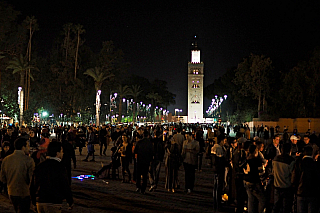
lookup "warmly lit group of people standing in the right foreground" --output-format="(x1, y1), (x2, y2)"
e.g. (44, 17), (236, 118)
(211, 128), (320, 213)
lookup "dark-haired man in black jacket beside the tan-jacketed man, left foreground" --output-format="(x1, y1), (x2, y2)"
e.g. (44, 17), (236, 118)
(30, 142), (73, 212)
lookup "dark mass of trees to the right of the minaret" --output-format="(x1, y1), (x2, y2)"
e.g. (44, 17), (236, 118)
(205, 48), (320, 123)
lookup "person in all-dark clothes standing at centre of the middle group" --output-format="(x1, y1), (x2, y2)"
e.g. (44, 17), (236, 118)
(134, 131), (154, 194)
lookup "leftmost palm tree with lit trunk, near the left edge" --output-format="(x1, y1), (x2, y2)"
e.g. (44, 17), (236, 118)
(6, 54), (37, 125)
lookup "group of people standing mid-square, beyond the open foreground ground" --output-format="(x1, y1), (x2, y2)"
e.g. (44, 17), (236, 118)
(93, 126), (204, 194)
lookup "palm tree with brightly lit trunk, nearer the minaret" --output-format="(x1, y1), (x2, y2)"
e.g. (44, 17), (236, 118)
(84, 67), (114, 126)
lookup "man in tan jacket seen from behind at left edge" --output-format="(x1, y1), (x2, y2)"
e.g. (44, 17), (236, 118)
(0, 138), (35, 213)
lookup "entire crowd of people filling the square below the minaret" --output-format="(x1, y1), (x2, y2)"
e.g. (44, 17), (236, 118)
(0, 124), (320, 213)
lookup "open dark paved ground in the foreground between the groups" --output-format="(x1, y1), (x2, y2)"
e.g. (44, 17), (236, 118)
(0, 141), (238, 213)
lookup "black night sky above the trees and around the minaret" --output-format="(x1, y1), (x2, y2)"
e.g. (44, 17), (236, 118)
(7, 0), (320, 114)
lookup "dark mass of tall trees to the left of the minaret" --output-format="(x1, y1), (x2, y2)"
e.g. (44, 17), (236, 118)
(0, 2), (175, 123)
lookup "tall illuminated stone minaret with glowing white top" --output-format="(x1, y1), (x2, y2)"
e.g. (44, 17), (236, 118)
(188, 36), (204, 123)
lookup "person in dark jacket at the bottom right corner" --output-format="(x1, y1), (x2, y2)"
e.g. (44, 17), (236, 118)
(291, 146), (320, 213)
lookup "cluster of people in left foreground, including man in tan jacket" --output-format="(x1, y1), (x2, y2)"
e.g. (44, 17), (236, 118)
(0, 126), (76, 213)
